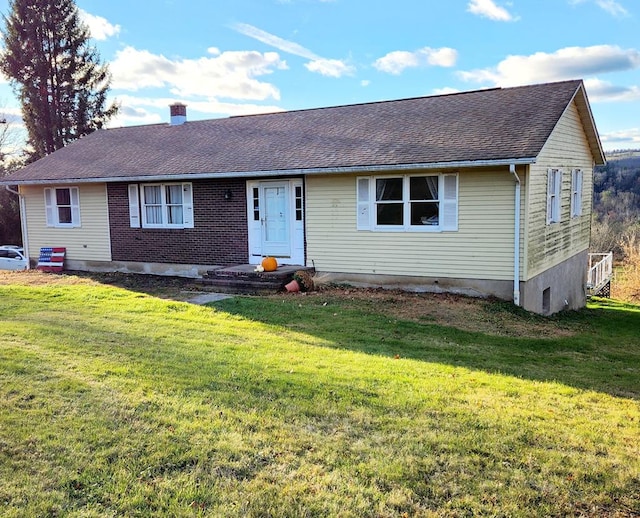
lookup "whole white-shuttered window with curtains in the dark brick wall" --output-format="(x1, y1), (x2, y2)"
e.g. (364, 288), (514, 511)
(129, 183), (193, 228)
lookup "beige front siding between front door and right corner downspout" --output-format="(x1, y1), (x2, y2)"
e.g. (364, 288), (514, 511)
(306, 168), (514, 280)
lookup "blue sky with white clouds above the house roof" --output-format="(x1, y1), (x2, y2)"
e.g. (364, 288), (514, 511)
(0, 0), (640, 150)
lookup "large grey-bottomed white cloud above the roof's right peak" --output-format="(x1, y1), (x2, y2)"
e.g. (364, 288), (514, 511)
(458, 45), (640, 86)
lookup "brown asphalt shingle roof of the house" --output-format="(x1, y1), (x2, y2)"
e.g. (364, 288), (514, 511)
(3, 80), (601, 183)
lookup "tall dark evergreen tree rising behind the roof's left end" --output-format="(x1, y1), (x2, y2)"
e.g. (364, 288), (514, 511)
(0, 0), (117, 160)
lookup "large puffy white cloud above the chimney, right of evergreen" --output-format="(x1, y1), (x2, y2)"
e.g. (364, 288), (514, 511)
(110, 47), (286, 100)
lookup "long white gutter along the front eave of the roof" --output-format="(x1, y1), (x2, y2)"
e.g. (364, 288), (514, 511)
(0, 157), (536, 185)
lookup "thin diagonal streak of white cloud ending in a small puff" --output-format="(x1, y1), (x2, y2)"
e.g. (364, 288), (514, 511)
(232, 23), (355, 77)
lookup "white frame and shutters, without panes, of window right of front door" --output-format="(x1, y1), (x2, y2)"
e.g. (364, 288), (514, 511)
(356, 173), (459, 232)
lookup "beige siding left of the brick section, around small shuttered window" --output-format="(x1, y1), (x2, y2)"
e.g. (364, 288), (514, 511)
(20, 184), (111, 261)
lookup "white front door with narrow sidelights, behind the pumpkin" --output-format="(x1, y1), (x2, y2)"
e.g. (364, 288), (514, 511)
(247, 179), (304, 264)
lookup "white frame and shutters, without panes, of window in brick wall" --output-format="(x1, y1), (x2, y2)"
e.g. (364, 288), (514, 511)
(128, 182), (194, 229)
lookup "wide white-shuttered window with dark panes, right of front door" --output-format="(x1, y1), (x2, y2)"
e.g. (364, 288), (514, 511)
(357, 174), (458, 232)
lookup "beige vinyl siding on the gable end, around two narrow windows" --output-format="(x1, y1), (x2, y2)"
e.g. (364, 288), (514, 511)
(526, 103), (593, 279)
